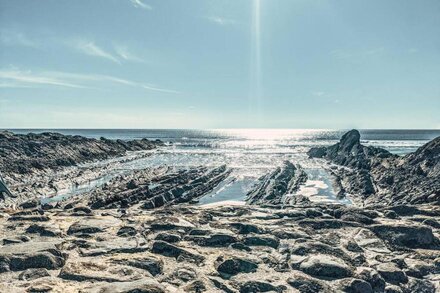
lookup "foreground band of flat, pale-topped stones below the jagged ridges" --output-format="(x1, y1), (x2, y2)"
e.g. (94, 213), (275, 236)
(0, 203), (440, 293)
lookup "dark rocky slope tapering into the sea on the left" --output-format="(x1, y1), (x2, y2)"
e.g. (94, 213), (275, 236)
(0, 131), (164, 205)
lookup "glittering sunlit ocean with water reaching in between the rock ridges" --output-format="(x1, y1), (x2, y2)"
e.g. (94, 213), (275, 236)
(6, 129), (440, 204)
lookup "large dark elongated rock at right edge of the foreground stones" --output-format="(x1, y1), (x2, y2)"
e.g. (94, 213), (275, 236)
(370, 225), (438, 248)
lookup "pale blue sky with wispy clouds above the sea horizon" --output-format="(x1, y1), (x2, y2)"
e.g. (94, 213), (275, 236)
(0, 0), (440, 128)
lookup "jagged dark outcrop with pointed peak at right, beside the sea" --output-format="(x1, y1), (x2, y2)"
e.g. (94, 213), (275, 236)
(308, 130), (440, 205)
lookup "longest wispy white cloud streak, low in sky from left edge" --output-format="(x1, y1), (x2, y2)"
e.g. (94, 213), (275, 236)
(0, 69), (179, 94)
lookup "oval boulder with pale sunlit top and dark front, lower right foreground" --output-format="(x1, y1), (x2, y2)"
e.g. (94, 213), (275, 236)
(299, 255), (353, 279)
